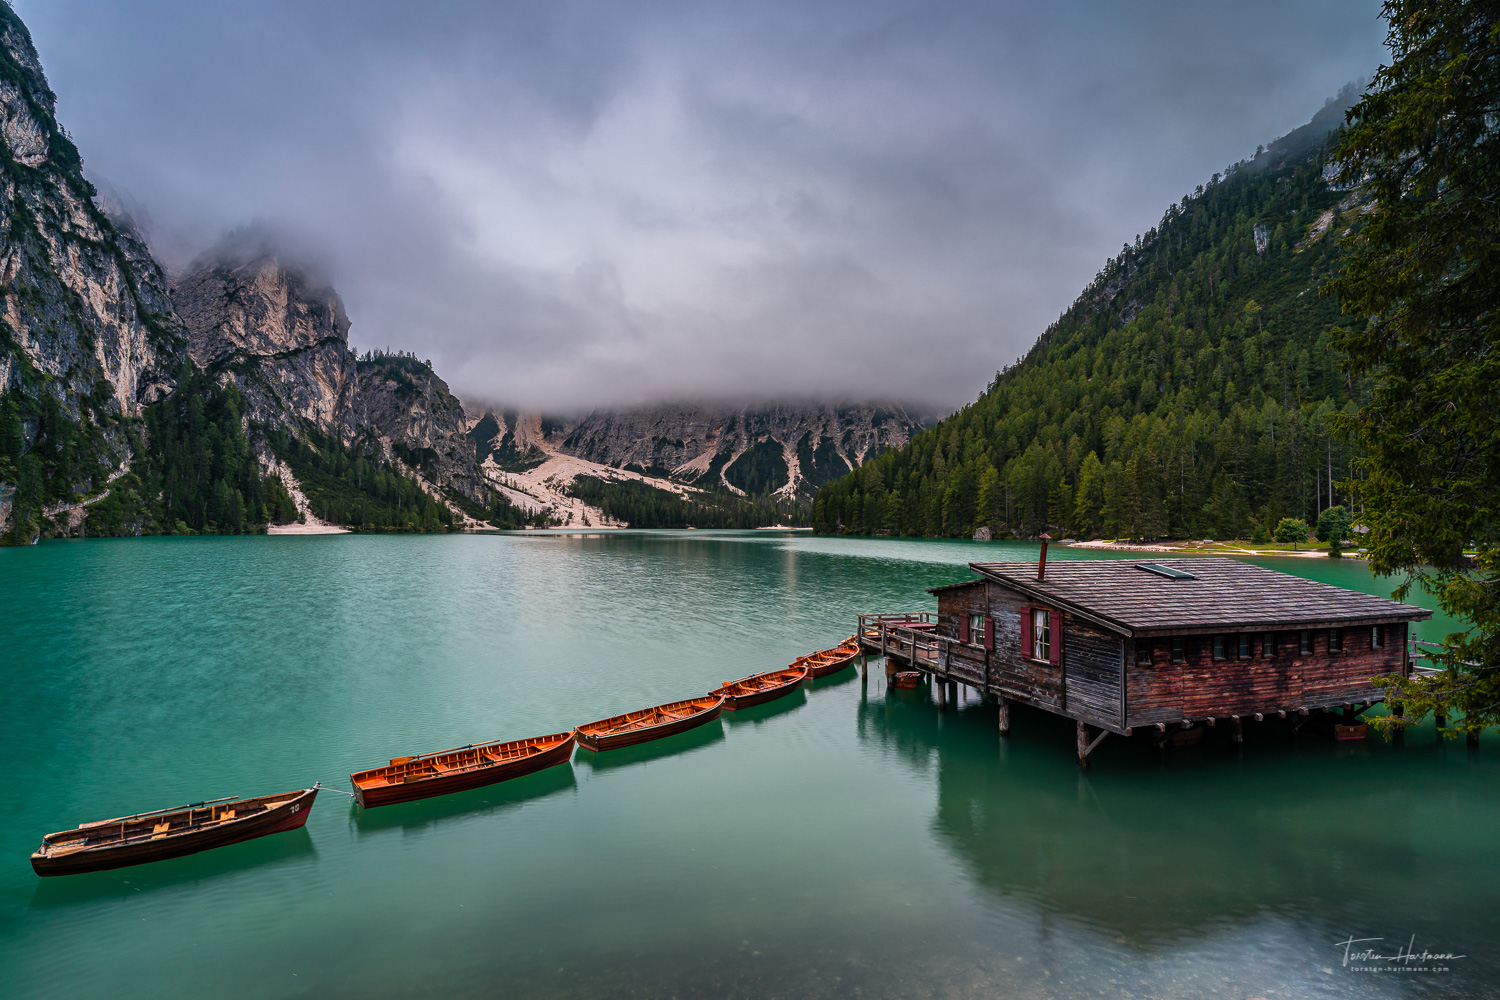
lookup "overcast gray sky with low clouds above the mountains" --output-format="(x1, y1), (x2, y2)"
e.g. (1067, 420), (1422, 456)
(14, 0), (1385, 409)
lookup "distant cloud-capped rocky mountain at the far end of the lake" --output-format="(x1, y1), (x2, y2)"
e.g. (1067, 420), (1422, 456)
(470, 403), (921, 499)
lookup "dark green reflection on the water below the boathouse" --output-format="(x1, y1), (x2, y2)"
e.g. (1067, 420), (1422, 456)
(858, 691), (1500, 973)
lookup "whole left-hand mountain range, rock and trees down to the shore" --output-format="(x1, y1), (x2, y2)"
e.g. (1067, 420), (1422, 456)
(0, 4), (504, 541)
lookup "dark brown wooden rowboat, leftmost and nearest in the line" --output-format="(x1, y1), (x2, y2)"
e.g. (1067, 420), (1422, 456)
(32, 784), (323, 876)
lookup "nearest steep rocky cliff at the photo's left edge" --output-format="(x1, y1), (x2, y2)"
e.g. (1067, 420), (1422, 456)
(0, 6), (188, 523)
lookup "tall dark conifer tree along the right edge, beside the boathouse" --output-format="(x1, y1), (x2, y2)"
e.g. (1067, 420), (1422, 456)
(1328, 0), (1500, 733)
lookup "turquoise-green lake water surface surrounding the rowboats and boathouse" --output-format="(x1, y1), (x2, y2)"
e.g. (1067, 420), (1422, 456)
(0, 532), (1500, 999)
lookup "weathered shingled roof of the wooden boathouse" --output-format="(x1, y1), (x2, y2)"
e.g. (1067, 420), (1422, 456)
(969, 556), (1433, 636)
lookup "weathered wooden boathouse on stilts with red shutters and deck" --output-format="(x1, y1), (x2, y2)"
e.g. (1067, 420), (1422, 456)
(858, 546), (1433, 763)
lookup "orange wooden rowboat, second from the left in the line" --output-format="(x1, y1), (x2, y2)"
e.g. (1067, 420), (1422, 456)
(350, 733), (573, 808)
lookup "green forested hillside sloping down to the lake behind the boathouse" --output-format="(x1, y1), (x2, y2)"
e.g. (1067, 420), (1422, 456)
(813, 90), (1364, 538)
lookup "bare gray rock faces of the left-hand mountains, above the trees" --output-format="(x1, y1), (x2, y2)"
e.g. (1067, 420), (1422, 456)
(0, 4), (488, 528)
